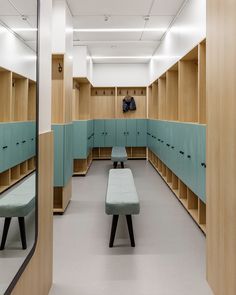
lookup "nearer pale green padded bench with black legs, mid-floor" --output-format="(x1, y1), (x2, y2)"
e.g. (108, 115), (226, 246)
(106, 169), (140, 248)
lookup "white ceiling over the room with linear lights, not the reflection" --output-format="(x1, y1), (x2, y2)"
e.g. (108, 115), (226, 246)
(67, 0), (186, 63)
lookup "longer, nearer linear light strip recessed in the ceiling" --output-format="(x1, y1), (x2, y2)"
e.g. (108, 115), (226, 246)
(74, 28), (167, 33)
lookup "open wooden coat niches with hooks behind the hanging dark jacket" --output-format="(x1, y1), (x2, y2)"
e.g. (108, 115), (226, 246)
(73, 82), (147, 120)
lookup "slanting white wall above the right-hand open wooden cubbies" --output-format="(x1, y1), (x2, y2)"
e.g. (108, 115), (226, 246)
(149, 0), (206, 82)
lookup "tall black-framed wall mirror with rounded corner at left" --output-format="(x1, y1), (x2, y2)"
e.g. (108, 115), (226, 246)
(0, 0), (38, 295)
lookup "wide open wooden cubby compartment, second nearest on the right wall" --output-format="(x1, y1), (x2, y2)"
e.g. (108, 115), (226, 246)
(178, 46), (198, 122)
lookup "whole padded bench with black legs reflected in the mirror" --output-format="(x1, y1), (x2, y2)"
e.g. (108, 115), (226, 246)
(0, 174), (35, 250)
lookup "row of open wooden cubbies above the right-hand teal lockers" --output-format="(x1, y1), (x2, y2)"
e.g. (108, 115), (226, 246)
(148, 40), (206, 124)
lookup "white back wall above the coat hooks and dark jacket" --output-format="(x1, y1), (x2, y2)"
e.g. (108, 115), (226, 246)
(92, 64), (149, 86)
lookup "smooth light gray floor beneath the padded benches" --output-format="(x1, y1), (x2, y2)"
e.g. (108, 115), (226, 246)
(50, 161), (212, 295)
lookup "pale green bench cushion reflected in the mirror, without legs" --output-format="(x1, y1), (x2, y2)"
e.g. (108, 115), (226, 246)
(0, 175), (35, 217)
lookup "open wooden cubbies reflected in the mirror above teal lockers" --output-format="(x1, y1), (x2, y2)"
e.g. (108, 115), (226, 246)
(0, 68), (36, 122)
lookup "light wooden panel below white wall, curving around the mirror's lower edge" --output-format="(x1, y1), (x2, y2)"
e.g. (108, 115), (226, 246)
(12, 132), (53, 295)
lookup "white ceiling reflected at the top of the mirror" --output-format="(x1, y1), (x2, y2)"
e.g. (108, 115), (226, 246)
(0, 0), (37, 50)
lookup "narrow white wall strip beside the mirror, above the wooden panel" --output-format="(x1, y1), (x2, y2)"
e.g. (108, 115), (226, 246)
(39, 0), (52, 133)
